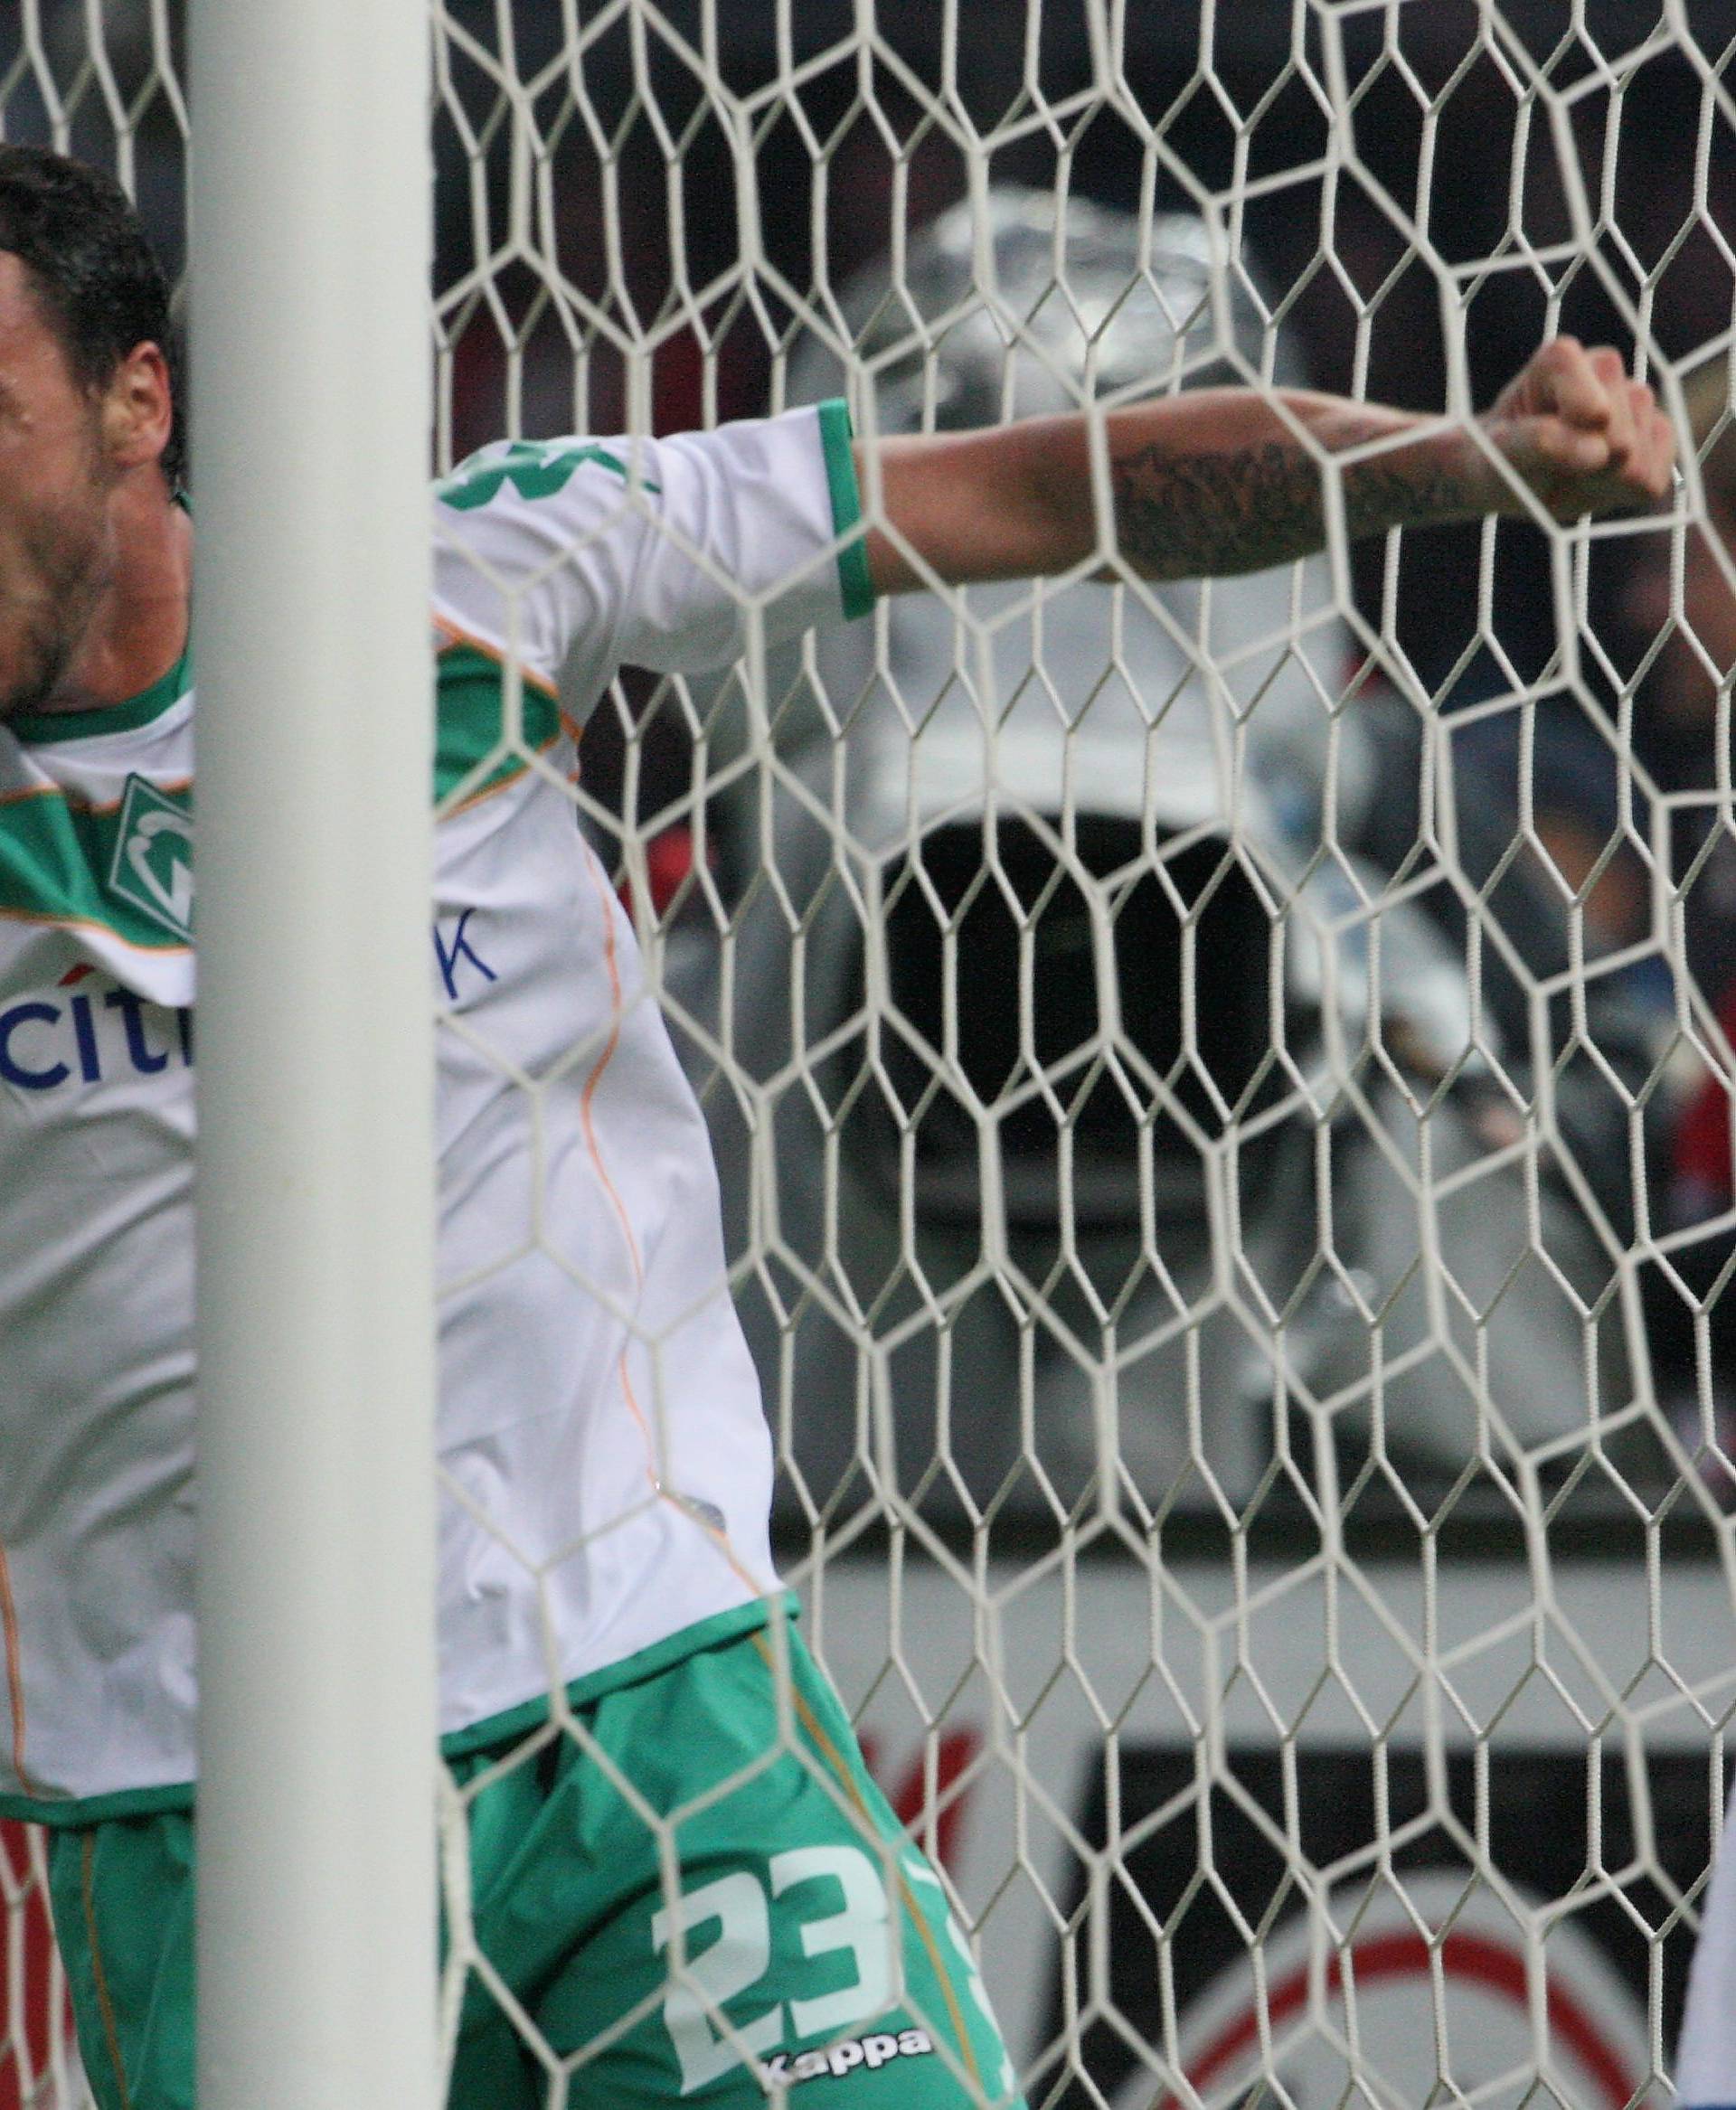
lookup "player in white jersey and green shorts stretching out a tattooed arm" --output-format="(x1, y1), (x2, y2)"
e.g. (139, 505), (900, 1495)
(0, 147), (1671, 2110)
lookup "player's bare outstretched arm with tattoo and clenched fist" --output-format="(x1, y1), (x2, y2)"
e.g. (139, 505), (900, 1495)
(856, 337), (1675, 593)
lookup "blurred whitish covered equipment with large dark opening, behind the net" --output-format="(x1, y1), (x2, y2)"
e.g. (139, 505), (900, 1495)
(663, 190), (1624, 1512)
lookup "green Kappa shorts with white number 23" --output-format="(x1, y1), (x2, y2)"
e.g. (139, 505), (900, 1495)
(51, 1621), (1016, 2110)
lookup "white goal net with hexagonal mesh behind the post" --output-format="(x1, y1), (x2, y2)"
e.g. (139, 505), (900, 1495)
(0, 0), (1736, 2110)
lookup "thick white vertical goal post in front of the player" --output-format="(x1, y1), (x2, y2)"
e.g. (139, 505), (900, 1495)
(188, 0), (437, 2110)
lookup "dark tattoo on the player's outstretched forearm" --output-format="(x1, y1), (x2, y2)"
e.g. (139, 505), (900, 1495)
(1111, 438), (1468, 579)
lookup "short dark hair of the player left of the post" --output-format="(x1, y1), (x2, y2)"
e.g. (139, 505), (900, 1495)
(0, 146), (185, 487)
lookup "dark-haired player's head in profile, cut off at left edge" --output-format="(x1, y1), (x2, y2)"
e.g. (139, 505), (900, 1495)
(0, 146), (179, 720)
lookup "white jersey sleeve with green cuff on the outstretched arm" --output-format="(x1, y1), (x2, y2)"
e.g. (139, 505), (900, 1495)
(435, 403), (873, 694)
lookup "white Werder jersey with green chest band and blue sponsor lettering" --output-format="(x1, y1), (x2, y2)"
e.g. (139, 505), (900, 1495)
(0, 405), (869, 1821)
